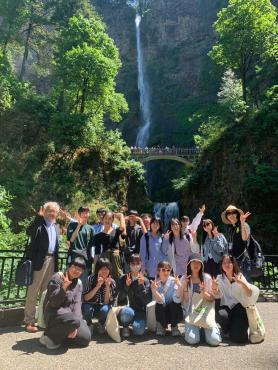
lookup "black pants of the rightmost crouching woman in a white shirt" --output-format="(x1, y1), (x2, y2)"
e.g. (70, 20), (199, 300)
(216, 303), (249, 343)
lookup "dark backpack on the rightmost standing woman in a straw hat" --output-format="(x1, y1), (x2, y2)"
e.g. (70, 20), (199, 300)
(247, 235), (265, 278)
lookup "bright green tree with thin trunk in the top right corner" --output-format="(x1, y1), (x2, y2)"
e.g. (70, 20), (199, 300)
(209, 0), (278, 101)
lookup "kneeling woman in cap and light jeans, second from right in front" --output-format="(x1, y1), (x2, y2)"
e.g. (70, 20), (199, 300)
(181, 253), (221, 346)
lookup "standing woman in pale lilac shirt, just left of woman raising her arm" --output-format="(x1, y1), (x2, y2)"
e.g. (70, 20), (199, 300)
(162, 218), (191, 276)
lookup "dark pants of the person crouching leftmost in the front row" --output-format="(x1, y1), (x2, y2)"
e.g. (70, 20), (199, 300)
(44, 313), (91, 347)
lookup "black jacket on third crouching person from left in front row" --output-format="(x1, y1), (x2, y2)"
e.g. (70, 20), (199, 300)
(118, 275), (151, 311)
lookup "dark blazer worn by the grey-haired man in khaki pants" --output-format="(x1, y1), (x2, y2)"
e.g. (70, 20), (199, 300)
(26, 215), (59, 272)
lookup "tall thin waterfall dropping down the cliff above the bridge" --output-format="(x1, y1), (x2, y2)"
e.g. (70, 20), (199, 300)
(135, 14), (151, 148)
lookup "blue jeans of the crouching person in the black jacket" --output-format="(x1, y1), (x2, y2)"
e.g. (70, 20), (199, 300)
(118, 306), (146, 335)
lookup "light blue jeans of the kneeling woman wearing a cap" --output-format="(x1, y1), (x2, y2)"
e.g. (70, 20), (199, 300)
(184, 322), (221, 346)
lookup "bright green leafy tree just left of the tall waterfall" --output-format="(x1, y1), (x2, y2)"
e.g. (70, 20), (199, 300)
(55, 15), (127, 117)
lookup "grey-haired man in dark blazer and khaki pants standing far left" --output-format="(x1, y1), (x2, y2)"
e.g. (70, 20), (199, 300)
(24, 202), (60, 333)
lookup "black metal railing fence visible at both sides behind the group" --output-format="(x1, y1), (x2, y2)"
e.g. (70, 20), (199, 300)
(0, 250), (278, 308)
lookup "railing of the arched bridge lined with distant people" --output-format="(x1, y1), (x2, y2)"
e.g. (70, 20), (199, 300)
(130, 147), (200, 156)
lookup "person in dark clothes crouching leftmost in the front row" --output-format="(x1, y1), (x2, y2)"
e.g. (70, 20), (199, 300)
(40, 257), (91, 349)
